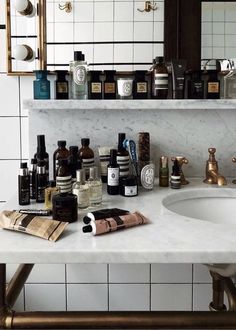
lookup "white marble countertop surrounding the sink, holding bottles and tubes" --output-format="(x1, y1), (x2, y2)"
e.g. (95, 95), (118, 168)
(0, 179), (236, 263)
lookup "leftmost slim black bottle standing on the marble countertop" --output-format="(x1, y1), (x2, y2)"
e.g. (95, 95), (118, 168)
(18, 163), (30, 205)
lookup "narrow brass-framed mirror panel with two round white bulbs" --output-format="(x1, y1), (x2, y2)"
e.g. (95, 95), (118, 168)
(6, 0), (46, 75)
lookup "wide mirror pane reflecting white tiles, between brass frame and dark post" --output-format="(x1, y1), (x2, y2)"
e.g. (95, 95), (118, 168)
(47, 0), (164, 71)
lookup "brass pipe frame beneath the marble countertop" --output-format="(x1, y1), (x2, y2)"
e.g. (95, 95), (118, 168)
(0, 264), (236, 329)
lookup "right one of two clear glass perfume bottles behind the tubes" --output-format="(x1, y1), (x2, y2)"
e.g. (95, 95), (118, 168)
(87, 166), (102, 206)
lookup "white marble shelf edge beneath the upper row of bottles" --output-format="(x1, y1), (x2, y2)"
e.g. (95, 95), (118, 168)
(23, 100), (236, 110)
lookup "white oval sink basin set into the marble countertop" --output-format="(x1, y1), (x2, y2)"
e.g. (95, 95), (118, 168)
(162, 188), (236, 225)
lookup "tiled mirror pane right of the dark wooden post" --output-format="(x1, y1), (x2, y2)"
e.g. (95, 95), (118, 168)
(201, 1), (236, 59)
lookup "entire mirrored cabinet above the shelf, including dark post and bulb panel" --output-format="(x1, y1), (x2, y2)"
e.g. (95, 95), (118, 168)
(6, 0), (236, 75)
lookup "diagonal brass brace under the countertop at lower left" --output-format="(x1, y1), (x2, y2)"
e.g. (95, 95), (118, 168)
(6, 264), (34, 307)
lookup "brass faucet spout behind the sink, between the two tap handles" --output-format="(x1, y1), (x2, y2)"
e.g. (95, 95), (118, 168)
(203, 148), (227, 186)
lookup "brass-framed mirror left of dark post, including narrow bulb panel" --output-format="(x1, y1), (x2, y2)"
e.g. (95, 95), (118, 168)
(6, 0), (173, 74)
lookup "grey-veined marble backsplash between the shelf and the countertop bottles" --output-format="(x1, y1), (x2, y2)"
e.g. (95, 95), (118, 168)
(26, 101), (236, 177)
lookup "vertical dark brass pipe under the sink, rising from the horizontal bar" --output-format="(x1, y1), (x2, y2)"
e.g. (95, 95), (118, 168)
(209, 272), (227, 312)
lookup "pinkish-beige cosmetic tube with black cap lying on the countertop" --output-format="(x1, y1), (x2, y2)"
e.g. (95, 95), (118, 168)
(83, 212), (149, 236)
